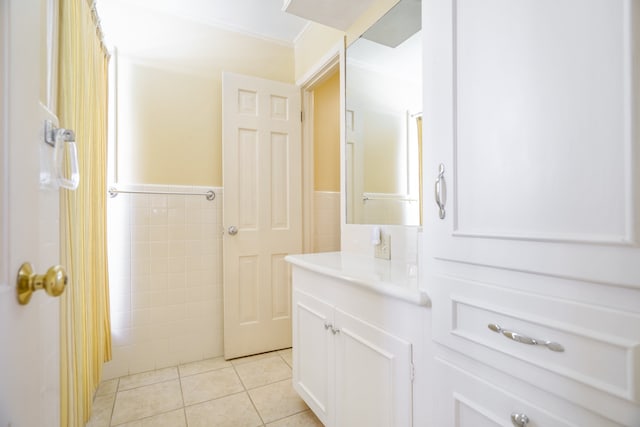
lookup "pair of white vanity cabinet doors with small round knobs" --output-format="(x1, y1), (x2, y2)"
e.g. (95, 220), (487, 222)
(293, 291), (412, 426)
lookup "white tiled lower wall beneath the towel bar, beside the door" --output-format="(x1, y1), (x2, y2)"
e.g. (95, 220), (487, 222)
(103, 185), (223, 379)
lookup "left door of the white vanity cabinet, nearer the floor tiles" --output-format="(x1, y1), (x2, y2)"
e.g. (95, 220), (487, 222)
(293, 290), (334, 426)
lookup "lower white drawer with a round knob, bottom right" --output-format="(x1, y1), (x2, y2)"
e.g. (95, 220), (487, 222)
(434, 359), (620, 427)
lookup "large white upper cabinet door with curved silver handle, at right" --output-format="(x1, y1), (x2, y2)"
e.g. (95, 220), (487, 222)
(423, 0), (640, 287)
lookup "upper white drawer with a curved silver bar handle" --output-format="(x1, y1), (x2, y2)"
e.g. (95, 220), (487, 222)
(432, 277), (640, 414)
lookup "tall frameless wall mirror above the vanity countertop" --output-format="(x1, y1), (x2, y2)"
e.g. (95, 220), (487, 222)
(345, 0), (422, 225)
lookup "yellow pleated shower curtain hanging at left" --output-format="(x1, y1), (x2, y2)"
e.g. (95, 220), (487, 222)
(58, 0), (111, 427)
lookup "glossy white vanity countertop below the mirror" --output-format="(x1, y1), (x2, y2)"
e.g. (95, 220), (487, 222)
(285, 252), (431, 306)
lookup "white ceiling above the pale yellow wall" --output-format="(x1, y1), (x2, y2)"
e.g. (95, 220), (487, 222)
(96, 0), (308, 45)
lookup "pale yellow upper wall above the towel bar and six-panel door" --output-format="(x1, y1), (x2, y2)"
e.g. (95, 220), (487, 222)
(116, 15), (294, 186)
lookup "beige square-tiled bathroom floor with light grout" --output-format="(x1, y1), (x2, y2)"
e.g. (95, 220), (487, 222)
(87, 349), (322, 427)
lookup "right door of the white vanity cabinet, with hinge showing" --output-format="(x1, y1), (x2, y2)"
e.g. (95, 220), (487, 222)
(334, 309), (413, 427)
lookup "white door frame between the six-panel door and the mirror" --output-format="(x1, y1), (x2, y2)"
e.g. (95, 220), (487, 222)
(296, 37), (346, 253)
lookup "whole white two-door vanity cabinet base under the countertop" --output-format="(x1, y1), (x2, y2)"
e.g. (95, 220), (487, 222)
(287, 254), (428, 427)
